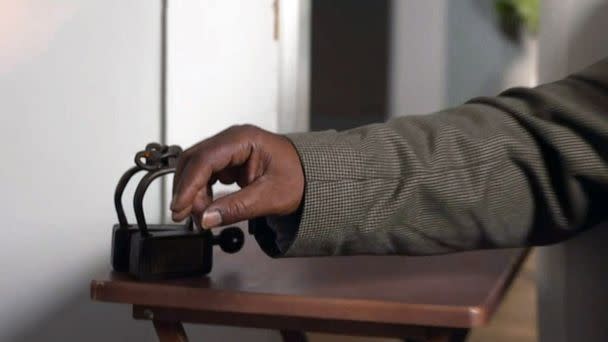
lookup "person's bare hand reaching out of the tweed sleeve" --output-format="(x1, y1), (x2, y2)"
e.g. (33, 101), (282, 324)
(171, 125), (304, 229)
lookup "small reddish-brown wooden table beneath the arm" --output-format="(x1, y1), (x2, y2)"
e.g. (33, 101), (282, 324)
(91, 226), (532, 342)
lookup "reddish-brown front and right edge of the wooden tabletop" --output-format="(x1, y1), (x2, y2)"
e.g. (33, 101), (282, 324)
(90, 249), (528, 328)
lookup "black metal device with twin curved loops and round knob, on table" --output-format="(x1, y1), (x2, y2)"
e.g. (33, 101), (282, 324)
(112, 143), (244, 280)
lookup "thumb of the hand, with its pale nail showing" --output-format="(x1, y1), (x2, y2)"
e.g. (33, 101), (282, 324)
(201, 181), (272, 229)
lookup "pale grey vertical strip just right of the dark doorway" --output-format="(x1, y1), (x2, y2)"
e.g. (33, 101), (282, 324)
(388, 0), (447, 116)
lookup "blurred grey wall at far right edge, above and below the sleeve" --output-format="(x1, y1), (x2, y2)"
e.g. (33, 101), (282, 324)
(538, 0), (608, 342)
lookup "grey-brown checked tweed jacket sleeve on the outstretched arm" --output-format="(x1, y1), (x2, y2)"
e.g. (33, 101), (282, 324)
(251, 59), (608, 256)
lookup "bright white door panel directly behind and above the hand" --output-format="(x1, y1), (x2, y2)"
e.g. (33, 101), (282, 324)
(167, 0), (278, 206)
